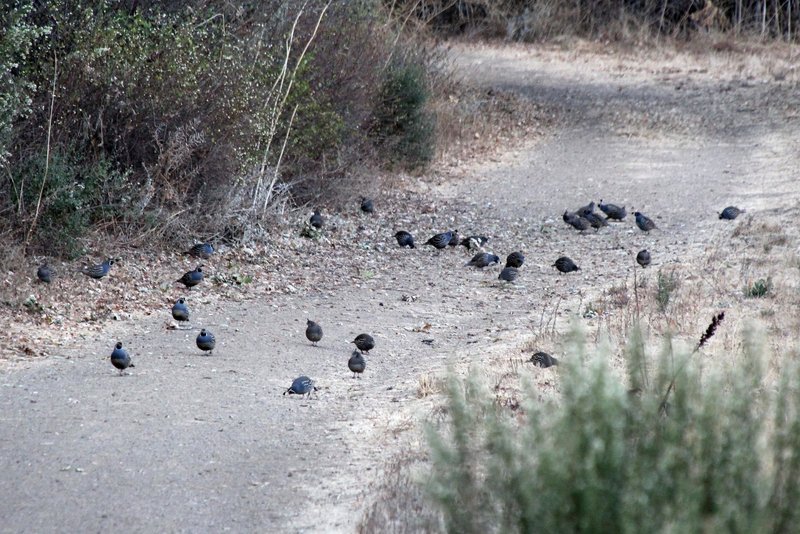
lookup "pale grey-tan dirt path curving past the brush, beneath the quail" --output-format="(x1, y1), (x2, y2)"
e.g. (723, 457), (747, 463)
(0, 43), (800, 532)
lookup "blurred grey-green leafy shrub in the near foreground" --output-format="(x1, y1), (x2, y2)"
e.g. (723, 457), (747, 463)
(429, 328), (800, 533)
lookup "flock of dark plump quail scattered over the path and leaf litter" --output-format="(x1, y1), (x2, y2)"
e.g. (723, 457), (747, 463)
(36, 197), (744, 396)
